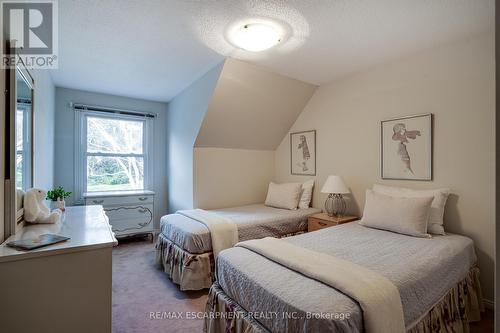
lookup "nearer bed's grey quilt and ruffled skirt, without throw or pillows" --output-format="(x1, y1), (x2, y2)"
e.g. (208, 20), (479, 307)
(205, 222), (482, 332)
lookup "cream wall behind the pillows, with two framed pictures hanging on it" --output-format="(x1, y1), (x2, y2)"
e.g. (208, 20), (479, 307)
(276, 33), (495, 300)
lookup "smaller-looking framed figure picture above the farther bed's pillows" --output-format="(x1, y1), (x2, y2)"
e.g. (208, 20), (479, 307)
(290, 130), (316, 176)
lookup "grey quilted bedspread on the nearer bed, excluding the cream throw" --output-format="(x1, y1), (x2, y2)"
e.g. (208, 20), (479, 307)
(217, 222), (476, 332)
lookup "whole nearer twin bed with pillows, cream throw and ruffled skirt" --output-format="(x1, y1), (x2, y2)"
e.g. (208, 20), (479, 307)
(205, 186), (482, 333)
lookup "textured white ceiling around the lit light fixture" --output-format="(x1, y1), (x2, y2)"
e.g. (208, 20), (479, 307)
(52, 0), (494, 101)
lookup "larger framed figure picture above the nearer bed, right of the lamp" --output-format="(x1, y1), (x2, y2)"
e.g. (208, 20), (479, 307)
(380, 113), (433, 181)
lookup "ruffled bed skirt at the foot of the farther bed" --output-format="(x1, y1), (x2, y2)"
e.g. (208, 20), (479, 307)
(156, 233), (214, 290)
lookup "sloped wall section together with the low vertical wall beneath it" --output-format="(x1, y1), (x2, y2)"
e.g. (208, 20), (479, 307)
(189, 59), (317, 209)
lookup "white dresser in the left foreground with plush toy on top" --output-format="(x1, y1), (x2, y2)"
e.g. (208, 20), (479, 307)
(0, 206), (117, 333)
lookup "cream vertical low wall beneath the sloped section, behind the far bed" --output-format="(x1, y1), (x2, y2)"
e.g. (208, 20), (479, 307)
(194, 148), (274, 209)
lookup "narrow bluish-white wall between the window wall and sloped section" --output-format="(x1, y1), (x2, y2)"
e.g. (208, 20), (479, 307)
(166, 63), (224, 212)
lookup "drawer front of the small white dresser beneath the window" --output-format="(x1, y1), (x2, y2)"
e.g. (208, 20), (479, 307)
(105, 204), (153, 236)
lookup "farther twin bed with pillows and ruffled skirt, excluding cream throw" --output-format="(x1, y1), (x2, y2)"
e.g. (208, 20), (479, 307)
(156, 180), (321, 290)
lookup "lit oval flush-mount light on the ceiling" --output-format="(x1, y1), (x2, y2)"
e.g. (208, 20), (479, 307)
(228, 21), (283, 52)
